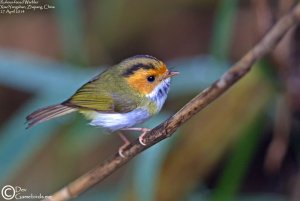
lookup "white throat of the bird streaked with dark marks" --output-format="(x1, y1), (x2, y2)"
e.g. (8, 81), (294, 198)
(146, 78), (171, 111)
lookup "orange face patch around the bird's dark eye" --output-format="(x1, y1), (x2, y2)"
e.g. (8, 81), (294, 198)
(125, 64), (168, 94)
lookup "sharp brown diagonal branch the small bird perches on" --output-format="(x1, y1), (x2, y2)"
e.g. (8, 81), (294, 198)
(44, 4), (300, 201)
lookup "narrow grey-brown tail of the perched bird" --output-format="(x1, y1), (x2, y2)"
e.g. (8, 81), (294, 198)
(26, 104), (77, 128)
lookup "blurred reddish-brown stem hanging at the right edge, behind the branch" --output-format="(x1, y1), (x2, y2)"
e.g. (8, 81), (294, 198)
(253, 0), (300, 175)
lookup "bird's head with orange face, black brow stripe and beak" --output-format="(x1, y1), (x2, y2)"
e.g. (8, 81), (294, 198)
(120, 55), (179, 95)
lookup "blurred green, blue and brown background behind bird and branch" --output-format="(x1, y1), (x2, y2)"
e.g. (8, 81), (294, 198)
(0, 0), (300, 201)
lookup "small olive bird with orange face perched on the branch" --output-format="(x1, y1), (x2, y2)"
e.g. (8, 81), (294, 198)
(26, 55), (179, 157)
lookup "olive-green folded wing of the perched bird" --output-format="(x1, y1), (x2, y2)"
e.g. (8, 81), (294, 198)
(64, 77), (137, 113)
